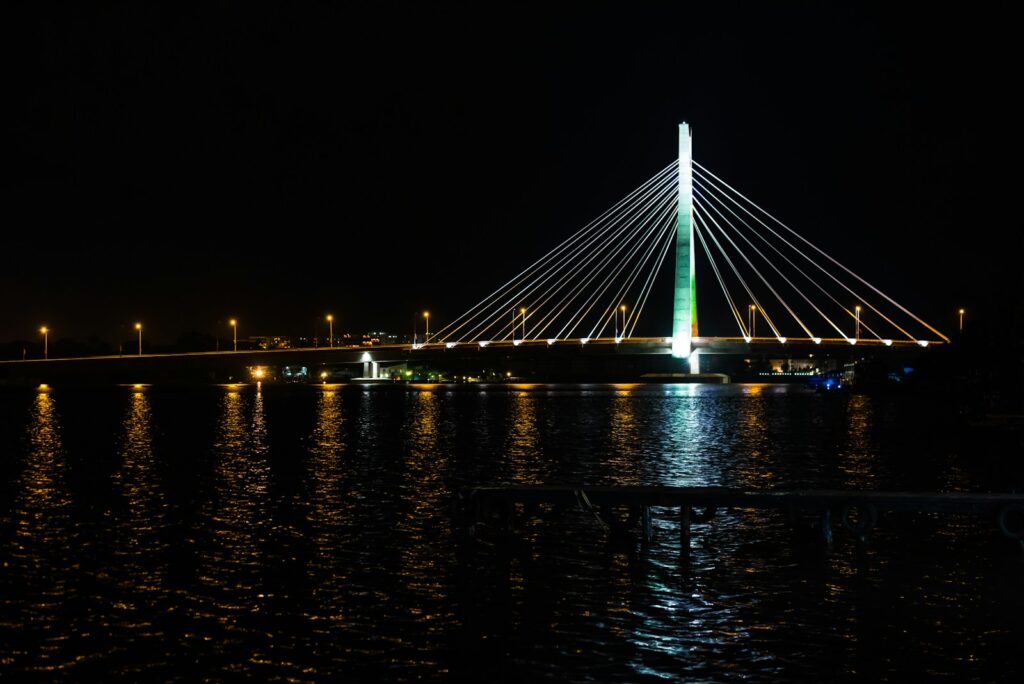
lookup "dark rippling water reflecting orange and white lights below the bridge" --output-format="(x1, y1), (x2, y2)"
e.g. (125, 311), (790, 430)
(0, 385), (1024, 681)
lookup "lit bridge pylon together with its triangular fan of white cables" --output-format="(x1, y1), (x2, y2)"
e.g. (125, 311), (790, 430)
(426, 123), (948, 362)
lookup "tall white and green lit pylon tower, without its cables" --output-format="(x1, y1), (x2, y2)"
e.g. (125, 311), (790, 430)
(672, 122), (697, 358)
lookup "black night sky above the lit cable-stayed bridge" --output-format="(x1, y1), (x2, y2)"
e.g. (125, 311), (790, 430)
(0, 2), (1024, 348)
